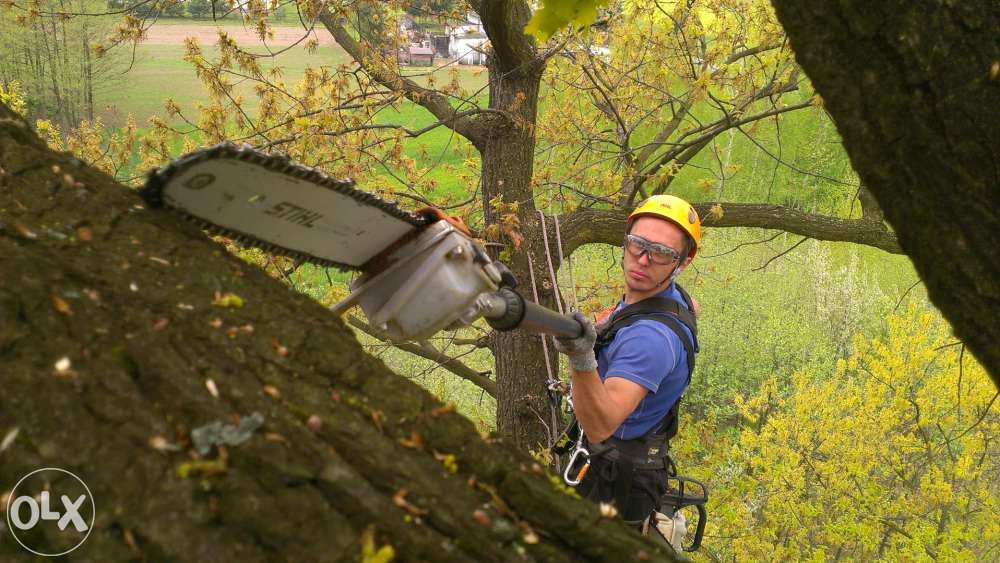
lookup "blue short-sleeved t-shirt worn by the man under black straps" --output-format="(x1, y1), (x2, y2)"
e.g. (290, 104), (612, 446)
(597, 283), (693, 440)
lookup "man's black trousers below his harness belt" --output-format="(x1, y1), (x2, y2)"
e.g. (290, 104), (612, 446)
(577, 457), (667, 526)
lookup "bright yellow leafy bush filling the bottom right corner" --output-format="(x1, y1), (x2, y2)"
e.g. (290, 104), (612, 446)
(678, 307), (1000, 561)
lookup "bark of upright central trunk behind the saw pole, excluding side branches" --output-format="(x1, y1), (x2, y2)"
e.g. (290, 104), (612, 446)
(474, 0), (562, 456)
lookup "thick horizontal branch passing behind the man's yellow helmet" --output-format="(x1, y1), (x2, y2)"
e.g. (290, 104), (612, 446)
(560, 203), (902, 254)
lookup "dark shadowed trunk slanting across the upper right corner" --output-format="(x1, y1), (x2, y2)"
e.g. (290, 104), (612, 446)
(773, 0), (1000, 386)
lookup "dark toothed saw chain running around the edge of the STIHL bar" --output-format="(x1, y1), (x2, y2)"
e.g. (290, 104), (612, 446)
(139, 143), (428, 270)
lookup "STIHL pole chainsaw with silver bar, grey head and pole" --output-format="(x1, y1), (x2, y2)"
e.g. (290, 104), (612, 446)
(139, 143), (583, 342)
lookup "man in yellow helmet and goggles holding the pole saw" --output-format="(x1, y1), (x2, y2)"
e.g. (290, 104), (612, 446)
(556, 195), (701, 540)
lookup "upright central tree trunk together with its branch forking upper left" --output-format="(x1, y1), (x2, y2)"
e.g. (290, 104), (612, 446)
(320, 0), (576, 451)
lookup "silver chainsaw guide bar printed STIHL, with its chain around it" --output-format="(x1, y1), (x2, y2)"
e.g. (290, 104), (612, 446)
(139, 143), (428, 270)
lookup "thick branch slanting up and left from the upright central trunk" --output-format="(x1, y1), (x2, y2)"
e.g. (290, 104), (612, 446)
(319, 10), (484, 146)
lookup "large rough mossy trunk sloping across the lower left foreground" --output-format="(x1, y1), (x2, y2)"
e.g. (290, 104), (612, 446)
(0, 105), (680, 562)
